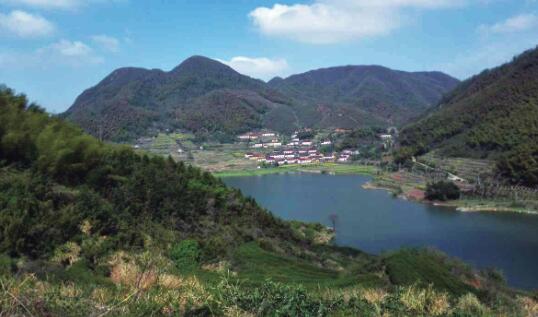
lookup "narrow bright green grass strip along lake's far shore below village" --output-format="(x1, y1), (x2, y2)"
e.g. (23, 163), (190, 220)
(214, 163), (378, 177)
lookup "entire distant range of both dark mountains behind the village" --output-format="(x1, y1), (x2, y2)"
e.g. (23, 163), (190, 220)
(62, 56), (457, 141)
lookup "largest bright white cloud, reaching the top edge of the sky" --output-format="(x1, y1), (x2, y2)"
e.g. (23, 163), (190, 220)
(249, 0), (462, 44)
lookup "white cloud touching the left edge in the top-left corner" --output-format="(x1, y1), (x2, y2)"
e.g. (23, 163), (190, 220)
(0, 10), (54, 37)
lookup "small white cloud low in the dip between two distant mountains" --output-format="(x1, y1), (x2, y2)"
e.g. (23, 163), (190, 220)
(219, 56), (289, 80)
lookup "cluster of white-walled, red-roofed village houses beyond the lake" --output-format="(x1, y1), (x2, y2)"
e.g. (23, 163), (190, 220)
(241, 130), (359, 167)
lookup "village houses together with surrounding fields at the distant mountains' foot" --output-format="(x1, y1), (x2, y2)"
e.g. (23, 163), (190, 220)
(132, 124), (397, 173)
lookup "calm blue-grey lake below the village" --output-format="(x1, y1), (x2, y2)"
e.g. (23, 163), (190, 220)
(223, 173), (538, 289)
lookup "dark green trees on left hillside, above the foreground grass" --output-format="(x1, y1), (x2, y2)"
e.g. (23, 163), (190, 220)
(0, 86), (290, 265)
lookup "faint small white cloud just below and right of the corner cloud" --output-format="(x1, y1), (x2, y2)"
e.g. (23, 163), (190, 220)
(36, 40), (104, 66)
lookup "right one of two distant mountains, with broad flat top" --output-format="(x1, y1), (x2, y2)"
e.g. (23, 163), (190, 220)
(268, 66), (458, 128)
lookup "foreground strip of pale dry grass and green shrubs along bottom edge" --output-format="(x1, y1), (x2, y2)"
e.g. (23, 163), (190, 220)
(0, 242), (538, 317)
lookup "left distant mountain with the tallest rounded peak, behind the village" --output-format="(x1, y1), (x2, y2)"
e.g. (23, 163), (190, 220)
(63, 56), (296, 140)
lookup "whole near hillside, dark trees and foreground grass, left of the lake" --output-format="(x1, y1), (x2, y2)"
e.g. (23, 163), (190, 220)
(0, 88), (537, 316)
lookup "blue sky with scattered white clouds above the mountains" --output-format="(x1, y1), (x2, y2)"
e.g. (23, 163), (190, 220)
(0, 0), (538, 113)
